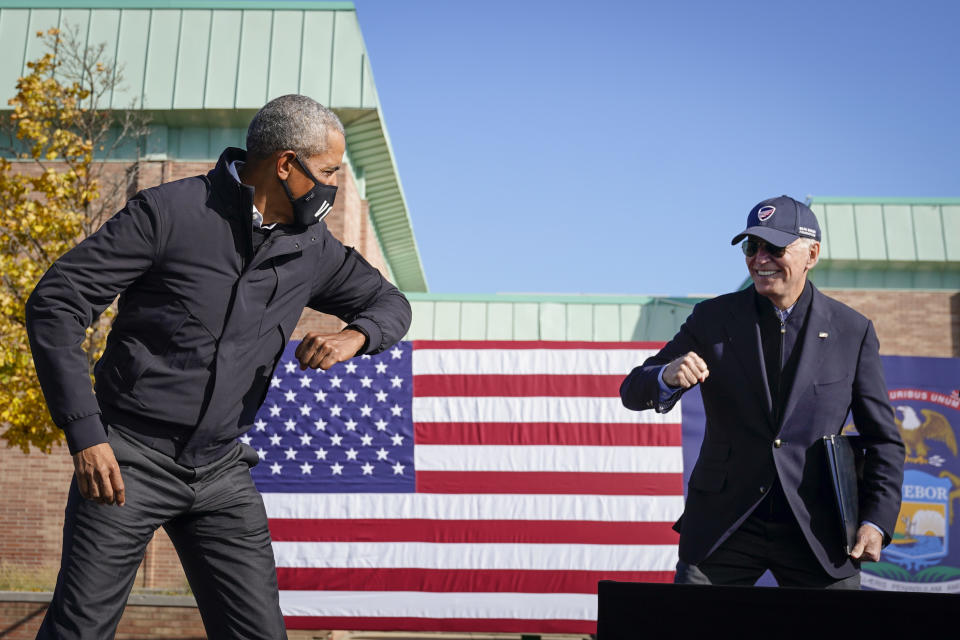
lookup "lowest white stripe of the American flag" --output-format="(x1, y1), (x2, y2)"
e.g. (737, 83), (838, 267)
(280, 591), (597, 620)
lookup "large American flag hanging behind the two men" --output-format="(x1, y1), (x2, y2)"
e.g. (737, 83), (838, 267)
(243, 341), (683, 633)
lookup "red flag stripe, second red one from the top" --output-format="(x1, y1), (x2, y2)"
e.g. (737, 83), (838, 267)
(413, 374), (624, 398)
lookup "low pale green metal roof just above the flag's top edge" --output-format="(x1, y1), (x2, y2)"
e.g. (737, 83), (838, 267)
(398, 293), (704, 342)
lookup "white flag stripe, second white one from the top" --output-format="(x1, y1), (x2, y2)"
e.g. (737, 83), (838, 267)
(413, 396), (680, 424)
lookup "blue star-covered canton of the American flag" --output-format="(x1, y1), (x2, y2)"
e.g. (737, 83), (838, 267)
(241, 342), (416, 494)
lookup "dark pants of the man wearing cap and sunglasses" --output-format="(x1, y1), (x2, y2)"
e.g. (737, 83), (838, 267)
(674, 514), (860, 589)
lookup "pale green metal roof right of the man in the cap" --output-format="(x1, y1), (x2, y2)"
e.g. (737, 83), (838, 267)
(809, 197), (960, 289)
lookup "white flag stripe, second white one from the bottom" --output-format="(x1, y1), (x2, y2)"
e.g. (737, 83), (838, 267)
(273, 541), (677, 571)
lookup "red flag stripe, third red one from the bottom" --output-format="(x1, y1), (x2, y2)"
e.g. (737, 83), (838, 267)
(270, 518), (678, 544)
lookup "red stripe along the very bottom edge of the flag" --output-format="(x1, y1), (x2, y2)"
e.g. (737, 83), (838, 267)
(283, 616), (597, 634)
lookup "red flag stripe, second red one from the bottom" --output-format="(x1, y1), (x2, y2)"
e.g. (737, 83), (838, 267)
(277, 567), (673, 593)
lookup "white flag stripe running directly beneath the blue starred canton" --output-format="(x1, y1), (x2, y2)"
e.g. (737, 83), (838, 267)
(263, 493), (683, 522)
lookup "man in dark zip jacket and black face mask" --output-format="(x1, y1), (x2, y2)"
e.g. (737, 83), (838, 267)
(27, 95), (410, 638)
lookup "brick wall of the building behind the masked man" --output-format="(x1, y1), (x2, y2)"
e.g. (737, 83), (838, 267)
(0, 152), (394, 604)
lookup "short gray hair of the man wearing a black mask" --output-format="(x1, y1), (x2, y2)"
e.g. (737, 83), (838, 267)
(247, 93), (343, 158)
